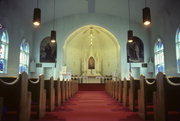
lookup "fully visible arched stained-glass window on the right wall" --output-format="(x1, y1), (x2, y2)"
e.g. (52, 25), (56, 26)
(154, 39), (165, 74)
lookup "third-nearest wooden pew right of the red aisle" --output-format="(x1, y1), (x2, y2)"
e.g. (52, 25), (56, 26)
(129, 76), (140, 111)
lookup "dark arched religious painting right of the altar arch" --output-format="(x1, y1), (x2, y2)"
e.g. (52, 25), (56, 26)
(127, 36), (144, 63)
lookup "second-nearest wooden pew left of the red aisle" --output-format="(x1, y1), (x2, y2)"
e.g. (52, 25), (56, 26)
(28, 75), (46, 119)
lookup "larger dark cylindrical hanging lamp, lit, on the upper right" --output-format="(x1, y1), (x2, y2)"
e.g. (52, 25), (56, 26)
(143, 0), (151, 26)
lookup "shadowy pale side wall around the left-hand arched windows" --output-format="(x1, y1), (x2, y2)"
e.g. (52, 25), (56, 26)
(0, 1), (33, 76)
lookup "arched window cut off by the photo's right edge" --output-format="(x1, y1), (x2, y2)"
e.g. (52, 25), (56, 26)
(176, 27), (180, 73)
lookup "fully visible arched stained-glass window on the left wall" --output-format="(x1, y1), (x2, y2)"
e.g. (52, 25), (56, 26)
(19, 39), (29, 73)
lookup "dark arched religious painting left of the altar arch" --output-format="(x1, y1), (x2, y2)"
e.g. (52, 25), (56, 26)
(40, 37), (57, 63)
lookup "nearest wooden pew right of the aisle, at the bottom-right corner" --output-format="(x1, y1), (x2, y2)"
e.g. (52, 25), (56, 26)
(153, 72), (180, 121)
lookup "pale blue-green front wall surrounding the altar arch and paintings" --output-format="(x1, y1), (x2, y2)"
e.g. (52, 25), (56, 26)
(34, 14), (149, 78)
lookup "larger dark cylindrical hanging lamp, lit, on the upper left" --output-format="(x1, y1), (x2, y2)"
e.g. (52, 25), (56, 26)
(33, 0), (41, 27)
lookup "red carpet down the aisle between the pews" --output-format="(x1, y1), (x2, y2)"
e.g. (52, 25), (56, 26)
(35, 91), (143, 121)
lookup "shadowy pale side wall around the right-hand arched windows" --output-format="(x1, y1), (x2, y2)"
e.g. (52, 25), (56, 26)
(151, 0), (180, 76)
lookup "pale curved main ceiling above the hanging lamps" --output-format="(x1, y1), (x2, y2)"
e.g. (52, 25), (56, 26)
(1, 0), (177, 23)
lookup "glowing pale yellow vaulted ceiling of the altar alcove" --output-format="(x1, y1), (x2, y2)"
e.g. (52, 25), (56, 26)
(64, 25), (120, 50)
